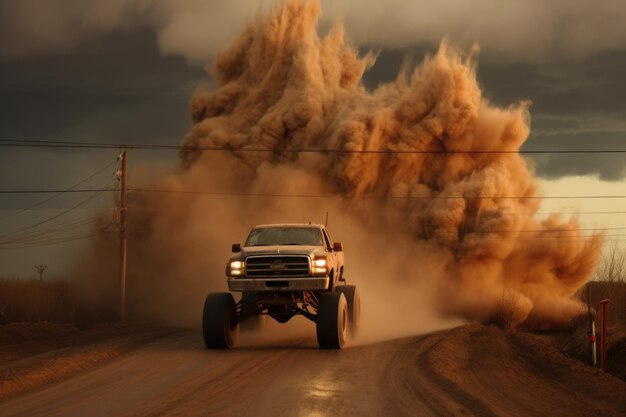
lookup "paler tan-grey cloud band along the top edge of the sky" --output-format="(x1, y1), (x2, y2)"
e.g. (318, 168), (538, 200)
(0, 0), (626, 62)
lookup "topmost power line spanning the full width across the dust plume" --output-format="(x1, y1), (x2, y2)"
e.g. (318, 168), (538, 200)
(0, 139), (626, 155)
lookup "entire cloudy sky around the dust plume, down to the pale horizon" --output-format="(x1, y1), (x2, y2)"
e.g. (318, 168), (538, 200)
(0, 0), (626, 277)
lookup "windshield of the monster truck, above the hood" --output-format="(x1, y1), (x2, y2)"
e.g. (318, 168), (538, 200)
(245, 227), (323, 246)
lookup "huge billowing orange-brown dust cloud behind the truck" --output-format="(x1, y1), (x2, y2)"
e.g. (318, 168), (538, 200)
(74, 0), (602, 334)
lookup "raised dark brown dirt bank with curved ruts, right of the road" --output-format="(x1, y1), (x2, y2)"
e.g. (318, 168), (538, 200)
(388, 324), (626, 417)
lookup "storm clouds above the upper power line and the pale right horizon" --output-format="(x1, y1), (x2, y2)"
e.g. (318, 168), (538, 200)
(0, 0), (626, 179)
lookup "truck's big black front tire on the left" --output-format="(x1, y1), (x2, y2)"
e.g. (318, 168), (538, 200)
(202, 292), (239, 349)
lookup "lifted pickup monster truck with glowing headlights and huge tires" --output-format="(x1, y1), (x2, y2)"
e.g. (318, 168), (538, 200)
(202, 224), (360, 349)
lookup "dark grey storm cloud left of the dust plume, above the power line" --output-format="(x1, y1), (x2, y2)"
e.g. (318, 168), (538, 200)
(0, 30), (204, 143)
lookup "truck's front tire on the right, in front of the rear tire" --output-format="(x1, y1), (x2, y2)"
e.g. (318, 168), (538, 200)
(316, 292), (349, 349)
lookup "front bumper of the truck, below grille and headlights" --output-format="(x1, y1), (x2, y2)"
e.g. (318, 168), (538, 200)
(228, 277), (330, 291)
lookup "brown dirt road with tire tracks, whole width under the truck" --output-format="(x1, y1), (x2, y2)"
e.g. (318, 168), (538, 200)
(0, 324), (626, 417)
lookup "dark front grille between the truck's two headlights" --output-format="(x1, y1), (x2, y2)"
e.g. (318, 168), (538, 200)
(246, 255), (309, 278)
